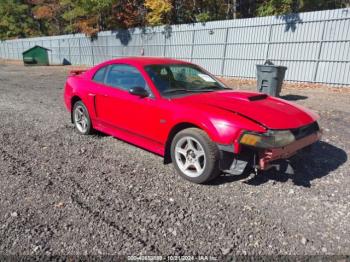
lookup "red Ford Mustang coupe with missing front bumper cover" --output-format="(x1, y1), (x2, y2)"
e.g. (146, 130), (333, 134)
(64, 57), (321, 183)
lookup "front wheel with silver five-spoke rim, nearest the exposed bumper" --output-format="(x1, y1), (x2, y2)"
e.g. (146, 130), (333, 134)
(170, 128), (221, 184)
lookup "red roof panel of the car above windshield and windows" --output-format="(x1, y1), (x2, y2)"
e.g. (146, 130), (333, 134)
(109, 56), (189, 66)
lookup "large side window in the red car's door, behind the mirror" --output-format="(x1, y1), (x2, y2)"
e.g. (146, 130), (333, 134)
(106, 65), (149, 91)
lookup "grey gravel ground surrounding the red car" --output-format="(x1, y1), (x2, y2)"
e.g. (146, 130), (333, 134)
(0, 64), (350, 256)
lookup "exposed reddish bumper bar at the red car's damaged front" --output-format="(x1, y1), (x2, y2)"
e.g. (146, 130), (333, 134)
(259, 131), (322, 170)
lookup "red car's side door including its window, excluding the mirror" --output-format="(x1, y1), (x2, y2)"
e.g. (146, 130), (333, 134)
(95, 64), (164, 143)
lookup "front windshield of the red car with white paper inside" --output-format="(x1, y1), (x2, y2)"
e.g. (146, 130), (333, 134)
(145, 64), (227, 96)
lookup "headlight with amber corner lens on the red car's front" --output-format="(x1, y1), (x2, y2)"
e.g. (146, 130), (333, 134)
(239, 130), (295, 148)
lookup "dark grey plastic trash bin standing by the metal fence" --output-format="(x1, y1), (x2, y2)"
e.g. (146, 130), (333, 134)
(256, 60), (287, 96)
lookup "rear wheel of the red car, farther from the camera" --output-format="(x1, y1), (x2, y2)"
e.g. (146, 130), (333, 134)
(72, 101), (93, 135)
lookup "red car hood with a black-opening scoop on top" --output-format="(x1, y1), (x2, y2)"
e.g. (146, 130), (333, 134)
(173, 91), (318, 129)
